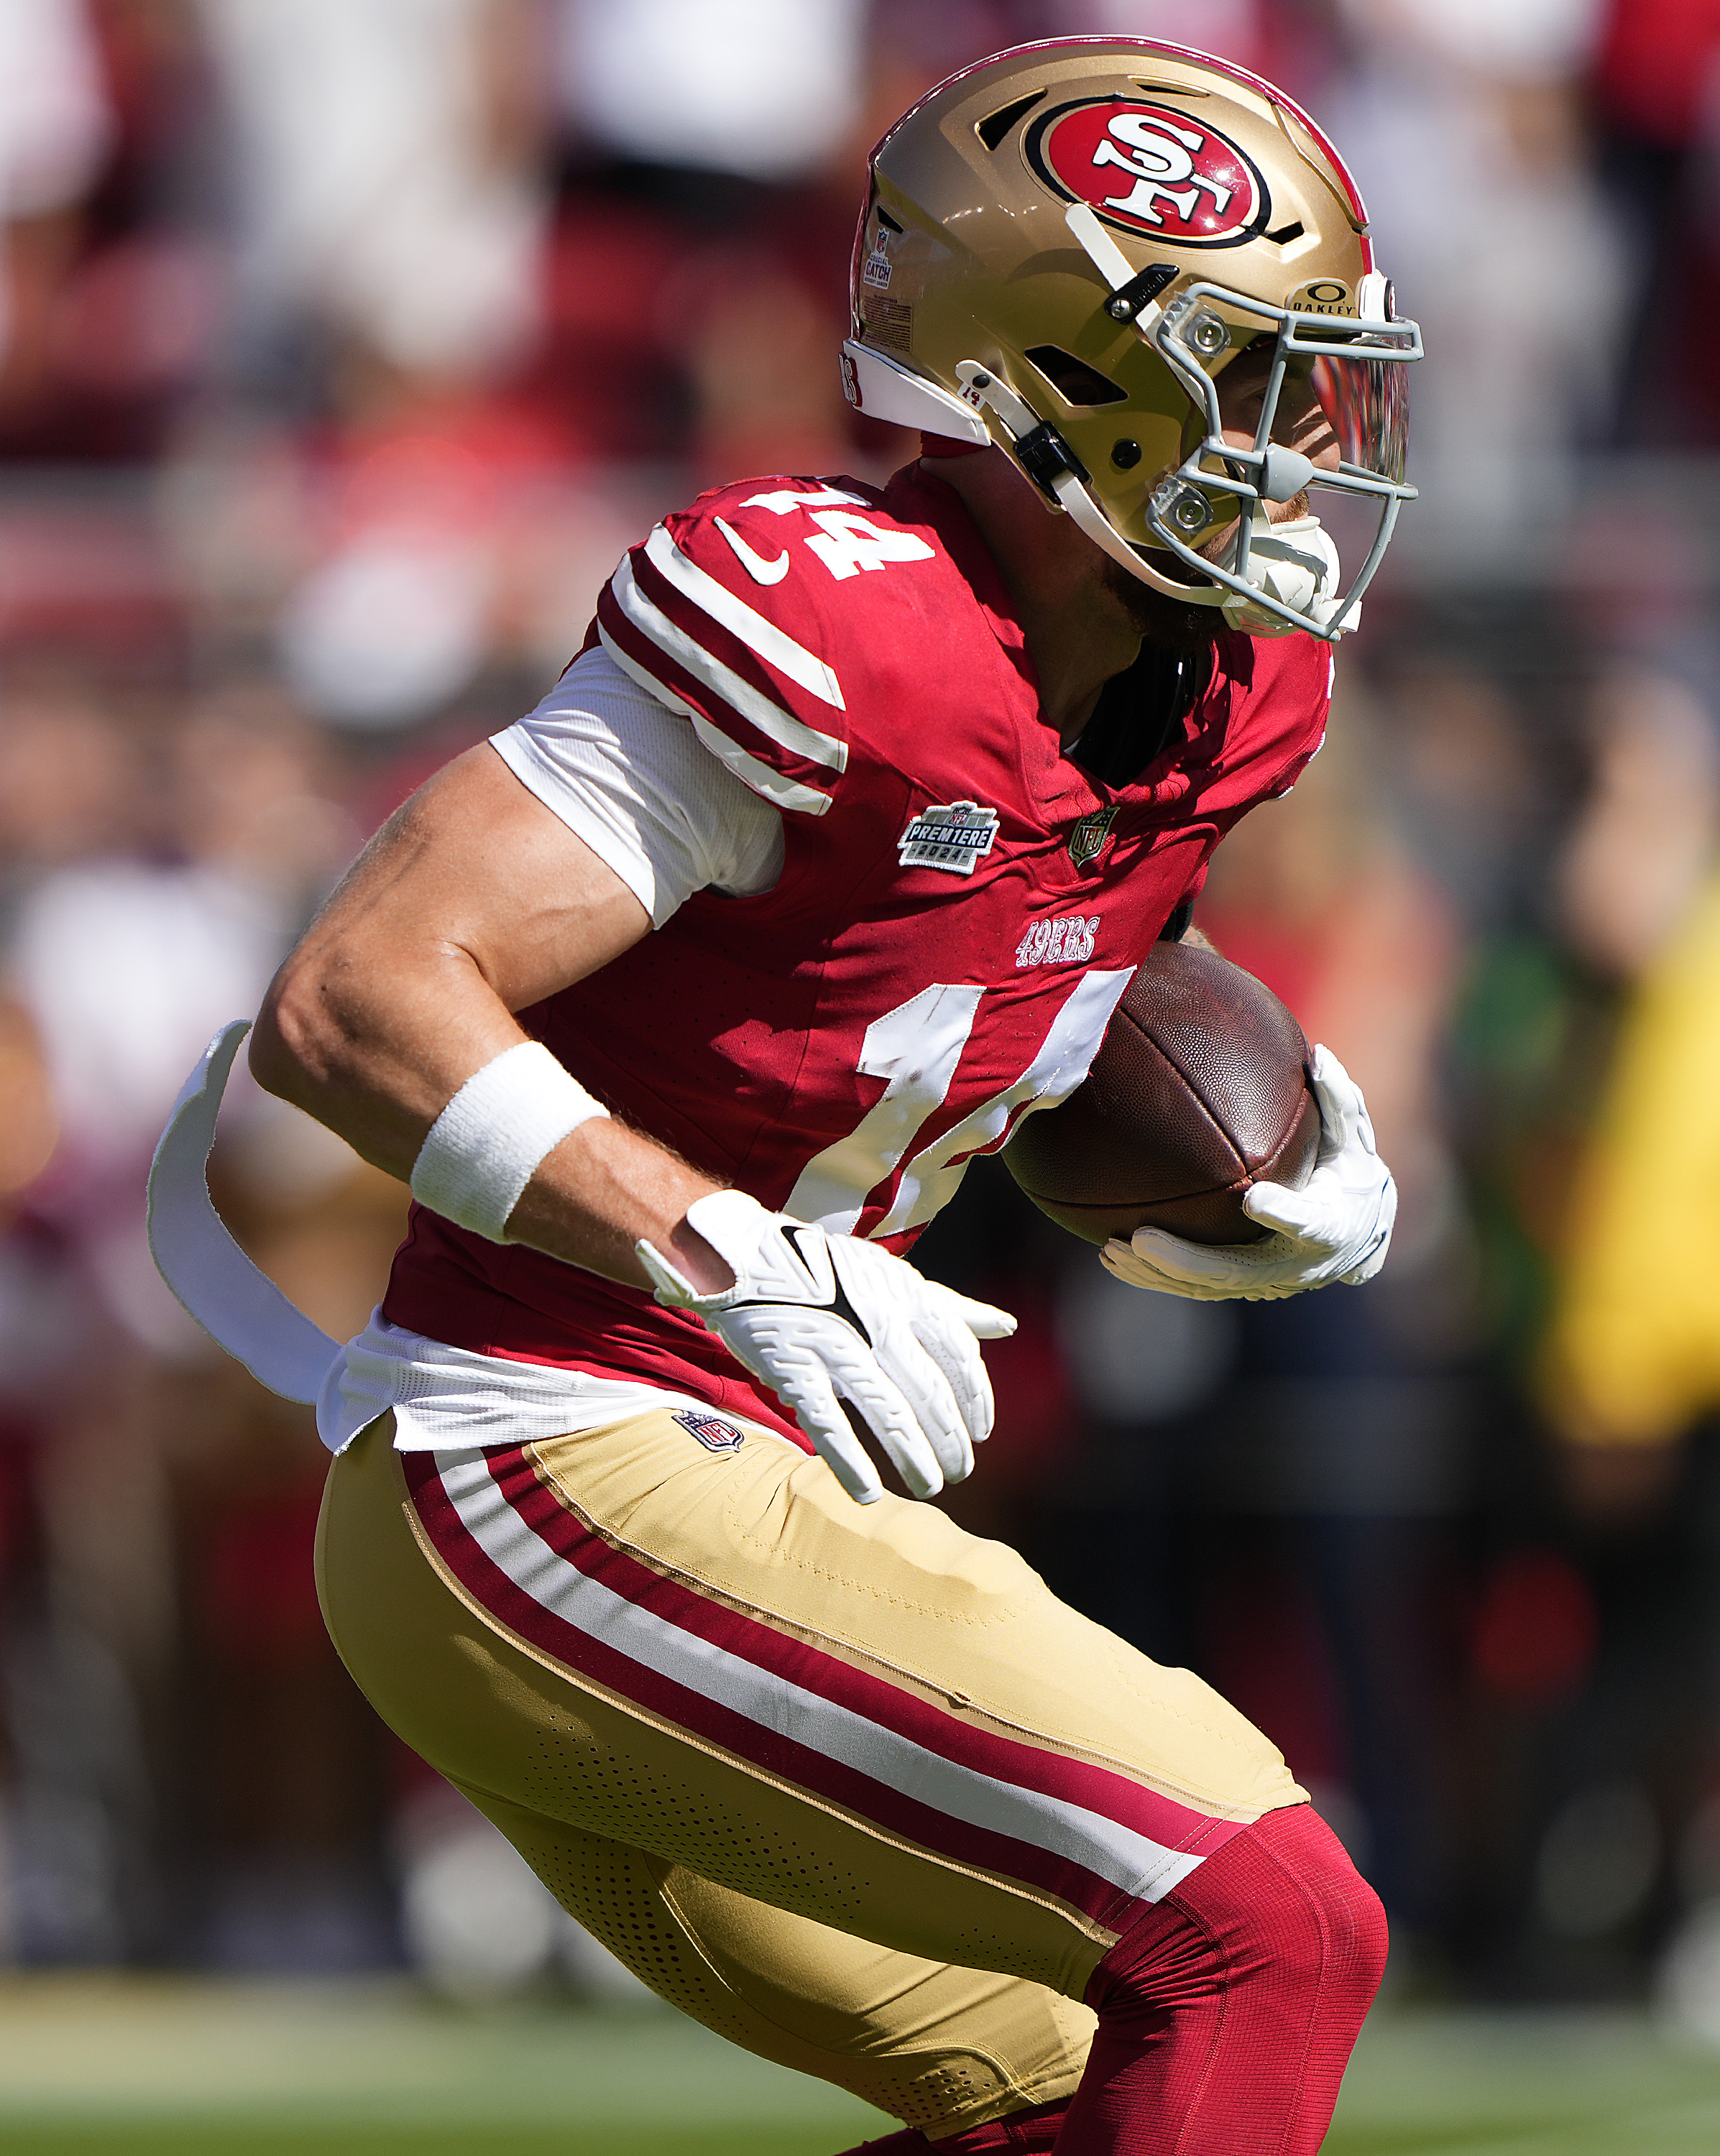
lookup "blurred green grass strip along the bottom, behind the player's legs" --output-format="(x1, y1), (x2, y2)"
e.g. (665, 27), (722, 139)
(0, 1977), (1720, 2156)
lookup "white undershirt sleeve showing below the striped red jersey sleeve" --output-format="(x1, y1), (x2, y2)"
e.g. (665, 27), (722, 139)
(492, 647), (783, 929)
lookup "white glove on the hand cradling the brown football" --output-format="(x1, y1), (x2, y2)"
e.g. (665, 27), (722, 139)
(1099, 1048), (1397, 1302)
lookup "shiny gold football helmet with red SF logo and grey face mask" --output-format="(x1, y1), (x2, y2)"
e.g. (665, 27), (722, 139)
(843, 37), (1420, 640)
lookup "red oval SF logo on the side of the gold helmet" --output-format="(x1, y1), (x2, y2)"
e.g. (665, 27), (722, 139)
(1026, 97), (1269, 248)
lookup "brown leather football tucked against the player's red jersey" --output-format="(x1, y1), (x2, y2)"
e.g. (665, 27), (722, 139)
(1004, 942), (1319, 1242)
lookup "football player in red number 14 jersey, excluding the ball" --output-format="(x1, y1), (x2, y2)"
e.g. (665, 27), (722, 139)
(155, 39), (1418, 2156)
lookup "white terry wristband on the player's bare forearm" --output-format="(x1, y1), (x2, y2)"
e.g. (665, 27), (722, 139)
(412, 1041), (610, 1242)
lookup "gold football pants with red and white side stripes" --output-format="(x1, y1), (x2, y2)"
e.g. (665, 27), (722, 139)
(317, 1414), (1353, 2156)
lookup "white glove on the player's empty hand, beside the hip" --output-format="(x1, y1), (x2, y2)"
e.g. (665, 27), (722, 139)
(634, 1190), (1015, 1505)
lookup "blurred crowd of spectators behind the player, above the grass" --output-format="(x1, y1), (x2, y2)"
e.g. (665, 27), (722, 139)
(0, 0), (1720, 2042)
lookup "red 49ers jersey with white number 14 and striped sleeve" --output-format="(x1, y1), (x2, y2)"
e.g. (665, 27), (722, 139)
(384, 466), (1330, 1432)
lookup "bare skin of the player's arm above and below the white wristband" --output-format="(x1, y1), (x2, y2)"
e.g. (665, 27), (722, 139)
(250, 744), (733, 1289)
